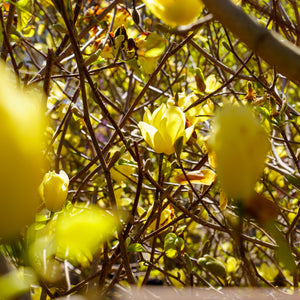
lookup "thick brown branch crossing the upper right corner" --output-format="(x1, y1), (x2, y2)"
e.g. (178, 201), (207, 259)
(202, 0), (300, 86)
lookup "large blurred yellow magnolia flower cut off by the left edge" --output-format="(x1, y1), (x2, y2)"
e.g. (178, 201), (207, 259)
(0, 62), (45, 237)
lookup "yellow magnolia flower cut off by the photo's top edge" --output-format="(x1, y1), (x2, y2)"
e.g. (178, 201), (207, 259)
(143, 0), (204, 27)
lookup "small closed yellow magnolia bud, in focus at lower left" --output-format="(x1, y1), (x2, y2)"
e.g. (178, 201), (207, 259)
(39, 170), (69, 212)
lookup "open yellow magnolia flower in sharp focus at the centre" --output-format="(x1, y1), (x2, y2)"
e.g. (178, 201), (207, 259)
(139, 104), (194, 155)
